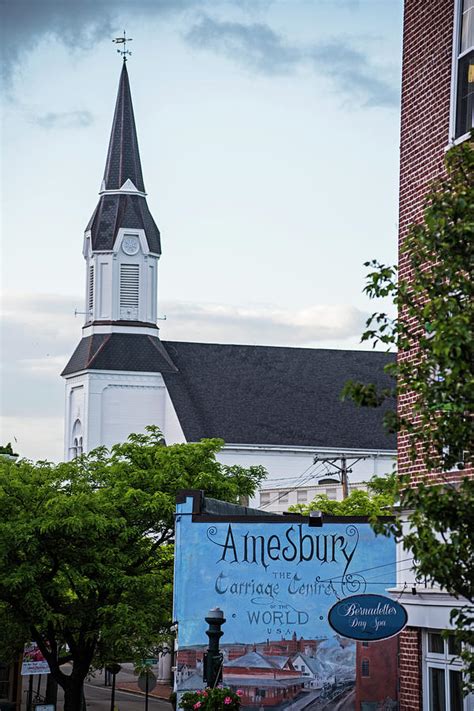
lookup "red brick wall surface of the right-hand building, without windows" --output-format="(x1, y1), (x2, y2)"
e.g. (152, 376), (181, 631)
(398, 0), (454, 711)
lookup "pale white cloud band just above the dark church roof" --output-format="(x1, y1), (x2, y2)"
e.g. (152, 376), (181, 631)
(161, 302), (367, 346)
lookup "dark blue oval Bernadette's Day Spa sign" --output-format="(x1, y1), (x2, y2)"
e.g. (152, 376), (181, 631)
(328, 595), (408, 642)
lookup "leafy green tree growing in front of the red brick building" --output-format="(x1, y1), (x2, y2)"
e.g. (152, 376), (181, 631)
(344, 134), (474, 688)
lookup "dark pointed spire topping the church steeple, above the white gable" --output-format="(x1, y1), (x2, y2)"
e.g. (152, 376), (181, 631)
(102, 62), (145, 192)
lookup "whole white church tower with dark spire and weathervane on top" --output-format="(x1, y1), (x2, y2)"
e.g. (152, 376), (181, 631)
(62, 51), (177, 459)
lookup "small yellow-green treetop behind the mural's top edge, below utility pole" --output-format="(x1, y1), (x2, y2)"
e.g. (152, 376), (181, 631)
(289, 474), (398, 522)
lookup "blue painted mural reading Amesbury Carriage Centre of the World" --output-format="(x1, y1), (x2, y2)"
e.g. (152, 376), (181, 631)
(174, 495), (397, 711)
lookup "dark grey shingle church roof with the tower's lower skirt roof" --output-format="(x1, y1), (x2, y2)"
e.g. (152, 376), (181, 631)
(63, 334), (396, 450)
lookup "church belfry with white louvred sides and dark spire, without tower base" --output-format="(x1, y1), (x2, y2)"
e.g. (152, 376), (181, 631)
(80, 62), (161, 335)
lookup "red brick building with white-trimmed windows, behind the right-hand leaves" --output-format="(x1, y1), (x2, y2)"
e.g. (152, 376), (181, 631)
(397, 0), (474, 711)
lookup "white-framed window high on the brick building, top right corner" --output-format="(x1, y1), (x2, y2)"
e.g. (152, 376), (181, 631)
(452, 0), (474, 139)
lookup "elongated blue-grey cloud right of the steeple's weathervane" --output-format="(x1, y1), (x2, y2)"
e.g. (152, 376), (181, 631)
(185, 15), (399, 108)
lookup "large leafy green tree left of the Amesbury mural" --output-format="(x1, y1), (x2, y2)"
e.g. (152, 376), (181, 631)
(0, 427), (265, 711)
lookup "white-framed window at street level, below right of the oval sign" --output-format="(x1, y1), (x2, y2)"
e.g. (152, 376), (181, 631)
(423, 630), (474, 711)
